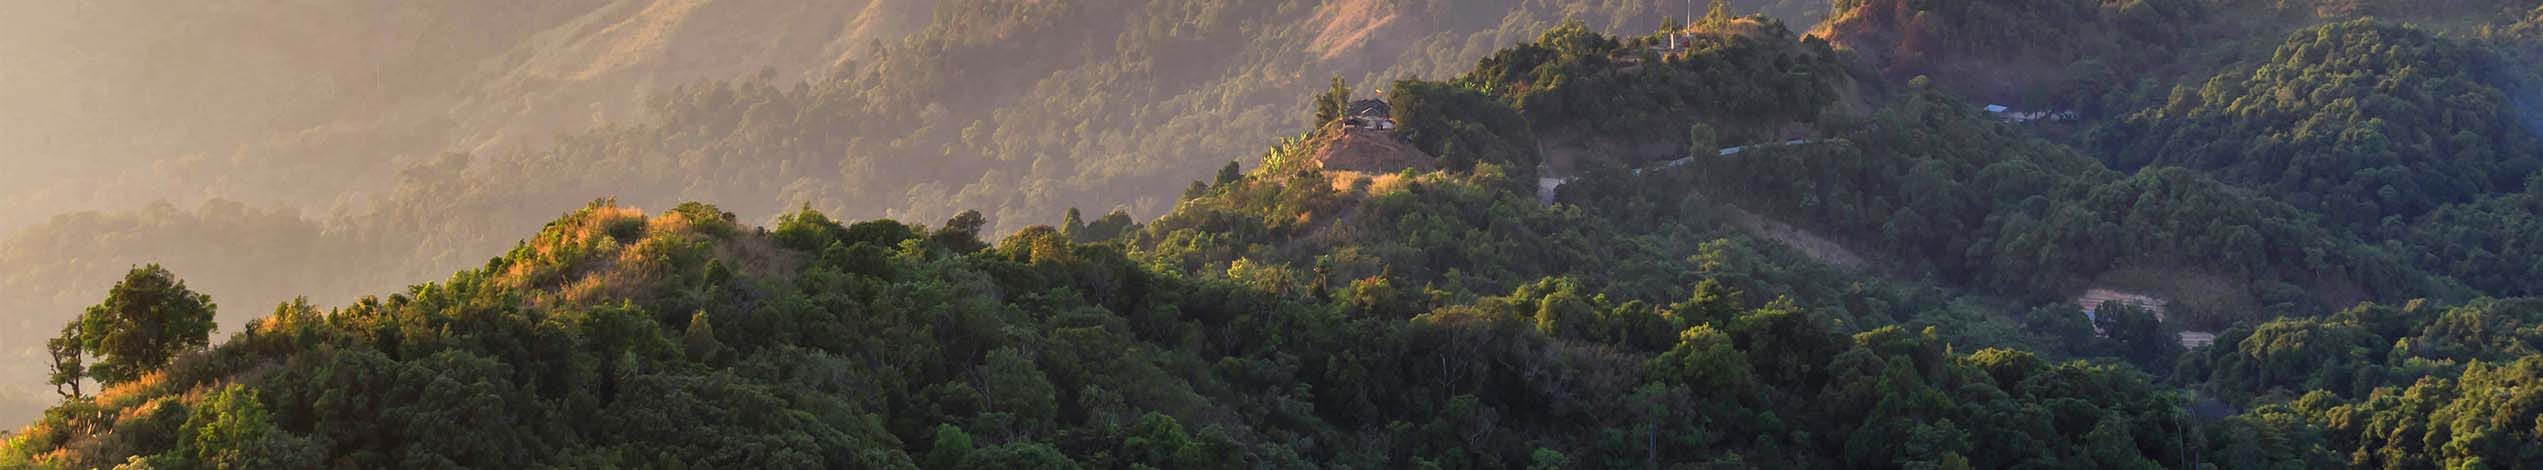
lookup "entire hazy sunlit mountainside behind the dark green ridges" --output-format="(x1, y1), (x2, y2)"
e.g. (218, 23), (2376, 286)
(0, 0), (1806, 426)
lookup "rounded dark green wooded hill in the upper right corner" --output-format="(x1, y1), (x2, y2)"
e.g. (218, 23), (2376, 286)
(2103, 20), (2543, 224)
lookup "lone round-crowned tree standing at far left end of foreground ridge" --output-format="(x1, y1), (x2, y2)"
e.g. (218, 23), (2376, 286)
(76, 264), (219, 386)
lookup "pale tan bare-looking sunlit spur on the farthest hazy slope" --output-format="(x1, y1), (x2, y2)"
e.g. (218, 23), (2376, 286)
(450, 0), (931, 150)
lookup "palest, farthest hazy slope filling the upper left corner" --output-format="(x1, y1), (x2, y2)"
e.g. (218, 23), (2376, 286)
(0, 0), (928, 229)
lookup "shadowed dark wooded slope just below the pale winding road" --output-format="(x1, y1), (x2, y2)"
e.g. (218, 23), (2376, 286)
(1694, 91), (2454, 323)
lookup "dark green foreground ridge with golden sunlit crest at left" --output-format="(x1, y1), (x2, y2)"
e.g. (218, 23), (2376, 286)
(0, 196), (2187, 467)
